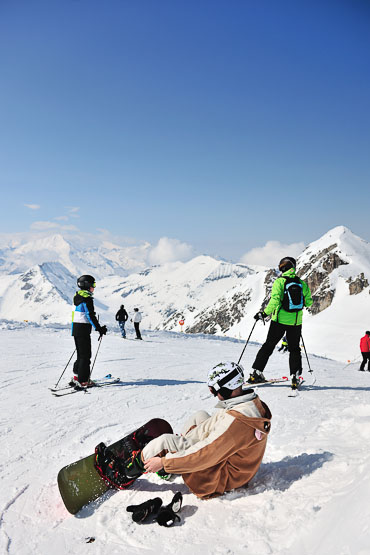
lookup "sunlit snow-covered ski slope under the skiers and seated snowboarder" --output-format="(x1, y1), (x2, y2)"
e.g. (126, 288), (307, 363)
(0, 327), (370, 555)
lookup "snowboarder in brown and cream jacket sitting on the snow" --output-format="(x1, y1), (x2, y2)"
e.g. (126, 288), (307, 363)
(98, 362), (271, 499)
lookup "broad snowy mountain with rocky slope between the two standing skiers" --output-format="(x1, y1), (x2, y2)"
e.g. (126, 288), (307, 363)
(97, 256), (264, 334)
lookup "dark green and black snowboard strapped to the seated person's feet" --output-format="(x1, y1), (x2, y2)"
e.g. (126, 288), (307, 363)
(58, 418), (173, 515)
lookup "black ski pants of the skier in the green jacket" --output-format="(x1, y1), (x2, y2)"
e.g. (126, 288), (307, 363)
(252, 321), (302, 374)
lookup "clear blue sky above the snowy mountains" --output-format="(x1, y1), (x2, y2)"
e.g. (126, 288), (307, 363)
(0, 0), (370, 260)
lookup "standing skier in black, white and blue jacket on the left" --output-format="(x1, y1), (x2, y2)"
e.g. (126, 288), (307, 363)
(72, 275), (107, 386)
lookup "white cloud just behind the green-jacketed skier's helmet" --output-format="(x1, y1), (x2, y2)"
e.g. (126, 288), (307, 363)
(240, 241), (305, 268)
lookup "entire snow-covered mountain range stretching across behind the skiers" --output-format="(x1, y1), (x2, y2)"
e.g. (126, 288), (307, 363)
(0, 226), (370, 359)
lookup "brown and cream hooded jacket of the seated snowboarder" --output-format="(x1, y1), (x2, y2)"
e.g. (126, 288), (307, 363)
(162, 393), (271, 499)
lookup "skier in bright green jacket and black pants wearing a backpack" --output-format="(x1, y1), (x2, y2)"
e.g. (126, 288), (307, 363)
(248, 256), (313, 386)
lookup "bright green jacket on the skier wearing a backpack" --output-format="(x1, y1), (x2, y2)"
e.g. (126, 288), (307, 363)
(264, 268), (313, 326)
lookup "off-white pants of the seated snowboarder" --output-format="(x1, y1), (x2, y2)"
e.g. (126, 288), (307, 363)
(142, 410), (210, 461)
